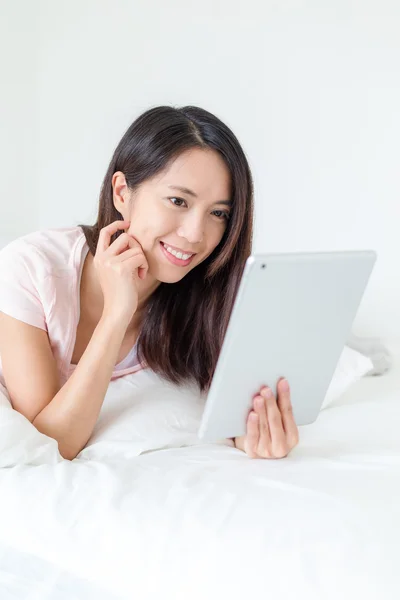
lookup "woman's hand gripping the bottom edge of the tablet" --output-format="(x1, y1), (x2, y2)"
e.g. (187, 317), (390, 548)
(234, 379), (299, 458)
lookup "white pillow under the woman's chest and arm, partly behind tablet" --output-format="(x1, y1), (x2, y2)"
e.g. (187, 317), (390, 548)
(0, 346), (372, 467)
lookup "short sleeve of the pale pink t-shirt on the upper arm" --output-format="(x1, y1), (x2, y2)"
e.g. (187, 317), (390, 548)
(0, 239), (47, 331)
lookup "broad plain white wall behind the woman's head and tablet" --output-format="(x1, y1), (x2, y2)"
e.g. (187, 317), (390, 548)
(0, 0), (400, 336)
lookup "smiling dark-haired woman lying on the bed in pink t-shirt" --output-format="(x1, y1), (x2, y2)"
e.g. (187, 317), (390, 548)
(0, 106), (298, 460)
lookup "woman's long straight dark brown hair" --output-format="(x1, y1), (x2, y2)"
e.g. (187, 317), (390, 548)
(81, 106), (253, 392)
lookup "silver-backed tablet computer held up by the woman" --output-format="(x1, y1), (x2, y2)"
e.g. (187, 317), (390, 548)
(198, 250), (377, 441)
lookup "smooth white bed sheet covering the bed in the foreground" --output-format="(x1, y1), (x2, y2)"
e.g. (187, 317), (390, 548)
(0, 345), (400, 600)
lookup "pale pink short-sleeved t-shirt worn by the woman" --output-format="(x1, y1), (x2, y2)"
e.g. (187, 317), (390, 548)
(0, 227), (143, 386)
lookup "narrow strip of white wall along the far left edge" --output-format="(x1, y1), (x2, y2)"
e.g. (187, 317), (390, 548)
(0, 0), (39, 247)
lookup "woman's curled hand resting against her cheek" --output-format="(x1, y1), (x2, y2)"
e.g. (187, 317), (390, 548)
(94, 221), (149, 325)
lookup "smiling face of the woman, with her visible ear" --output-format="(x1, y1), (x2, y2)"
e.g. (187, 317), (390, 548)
(113, 148), (231, 283)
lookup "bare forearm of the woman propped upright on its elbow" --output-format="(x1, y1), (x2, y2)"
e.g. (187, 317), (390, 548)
(33, 316), (127, 460)
